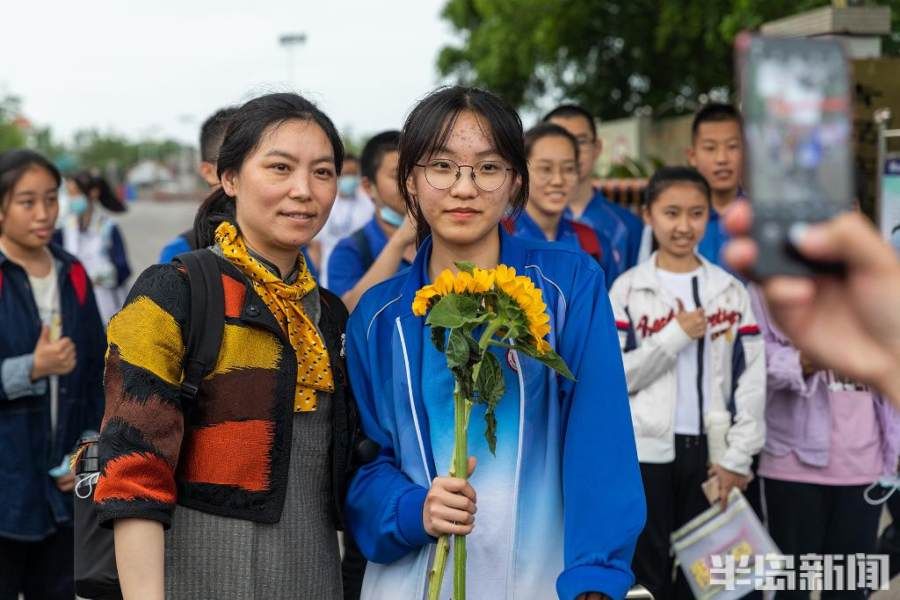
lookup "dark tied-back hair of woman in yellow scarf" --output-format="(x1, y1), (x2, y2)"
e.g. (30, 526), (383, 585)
(194, 92), (344, 248)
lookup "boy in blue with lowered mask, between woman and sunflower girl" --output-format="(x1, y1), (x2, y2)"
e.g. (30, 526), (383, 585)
(327, 130), (416, 311)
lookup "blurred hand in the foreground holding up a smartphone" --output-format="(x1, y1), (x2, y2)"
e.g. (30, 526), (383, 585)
(724, 202), (900, 409)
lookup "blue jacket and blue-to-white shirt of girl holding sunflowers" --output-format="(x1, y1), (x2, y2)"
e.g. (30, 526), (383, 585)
(346, 231), (646, 600)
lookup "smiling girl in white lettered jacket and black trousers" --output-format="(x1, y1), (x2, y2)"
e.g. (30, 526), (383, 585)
(610, 167), (766, 598)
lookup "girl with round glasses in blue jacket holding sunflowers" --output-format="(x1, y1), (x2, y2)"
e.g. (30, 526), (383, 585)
(346, 87), (645, 600)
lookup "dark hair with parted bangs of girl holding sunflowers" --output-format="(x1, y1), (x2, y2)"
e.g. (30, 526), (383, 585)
(397, 86), (528, 244)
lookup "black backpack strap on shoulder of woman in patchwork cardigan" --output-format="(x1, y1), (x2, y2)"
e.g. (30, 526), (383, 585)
(175, 249), (225, 403)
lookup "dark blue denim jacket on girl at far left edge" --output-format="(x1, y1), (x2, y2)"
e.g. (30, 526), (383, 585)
(0, 244), (106, 541)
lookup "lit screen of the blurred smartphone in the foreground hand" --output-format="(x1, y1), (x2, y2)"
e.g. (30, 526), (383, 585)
(742, 38), (853, 211)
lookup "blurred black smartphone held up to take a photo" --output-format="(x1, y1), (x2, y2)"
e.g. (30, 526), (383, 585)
(736, 34), (855, 278)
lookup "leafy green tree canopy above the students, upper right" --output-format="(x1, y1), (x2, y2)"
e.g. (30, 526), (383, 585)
(437, 0), (900, 119)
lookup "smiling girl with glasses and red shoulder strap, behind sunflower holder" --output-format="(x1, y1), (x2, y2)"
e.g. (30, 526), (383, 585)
(503, 123), (614, 285)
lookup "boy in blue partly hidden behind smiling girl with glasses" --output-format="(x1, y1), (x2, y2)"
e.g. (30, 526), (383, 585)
(543, 104), (644, 285)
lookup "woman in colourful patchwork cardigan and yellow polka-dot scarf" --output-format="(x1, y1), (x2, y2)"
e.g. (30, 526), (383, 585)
(94, 94), (350, 600)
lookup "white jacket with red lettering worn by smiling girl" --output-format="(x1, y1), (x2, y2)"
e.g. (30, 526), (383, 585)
(610, 253), (766, 474)
